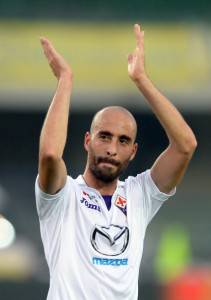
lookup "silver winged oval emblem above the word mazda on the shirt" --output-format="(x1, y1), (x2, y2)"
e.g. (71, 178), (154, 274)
(91, 224), (129, 256)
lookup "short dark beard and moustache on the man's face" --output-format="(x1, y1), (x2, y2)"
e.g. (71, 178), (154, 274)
(89, 156), (130, 183)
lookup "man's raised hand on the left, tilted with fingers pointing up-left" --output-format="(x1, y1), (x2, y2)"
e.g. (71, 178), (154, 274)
(40, 37), (73, 80)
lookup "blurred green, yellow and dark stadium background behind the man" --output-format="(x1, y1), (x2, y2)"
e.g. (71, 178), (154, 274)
(0, 0), (211, 300)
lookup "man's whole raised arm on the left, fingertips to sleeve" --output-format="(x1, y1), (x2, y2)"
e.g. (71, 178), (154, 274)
(39, 38), (73, 194)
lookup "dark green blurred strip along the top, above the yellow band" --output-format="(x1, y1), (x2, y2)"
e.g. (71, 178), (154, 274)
(0, 0), (211, 21)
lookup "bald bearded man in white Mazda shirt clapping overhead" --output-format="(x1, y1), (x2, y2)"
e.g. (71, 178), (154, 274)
(36, 24), (196, 300)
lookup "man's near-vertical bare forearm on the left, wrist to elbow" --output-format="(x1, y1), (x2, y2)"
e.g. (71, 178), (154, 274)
(40, 76), (72, 158)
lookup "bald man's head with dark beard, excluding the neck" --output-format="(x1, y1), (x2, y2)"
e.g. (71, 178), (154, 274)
(84, 106), (137, 183)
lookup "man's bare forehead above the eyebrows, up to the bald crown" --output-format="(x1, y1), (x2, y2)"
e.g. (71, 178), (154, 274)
(93, 110), (136, 138)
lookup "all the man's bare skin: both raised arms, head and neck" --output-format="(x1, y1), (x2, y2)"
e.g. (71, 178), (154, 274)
(39, 24), (197, 195)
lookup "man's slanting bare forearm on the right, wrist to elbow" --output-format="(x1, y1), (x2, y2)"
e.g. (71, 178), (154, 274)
(134, 74), (196, 153)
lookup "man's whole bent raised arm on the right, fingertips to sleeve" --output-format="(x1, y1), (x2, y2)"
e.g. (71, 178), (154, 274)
(128, 24), (197, 193)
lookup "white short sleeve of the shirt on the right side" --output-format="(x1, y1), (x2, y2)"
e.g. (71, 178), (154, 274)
(135, 170), (176, 224)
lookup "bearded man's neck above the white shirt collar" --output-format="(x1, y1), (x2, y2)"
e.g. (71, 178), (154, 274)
(83, 168), (118, 195)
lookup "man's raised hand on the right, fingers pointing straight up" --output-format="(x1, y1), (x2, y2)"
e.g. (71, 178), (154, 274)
(128, 24), (146, 81)
